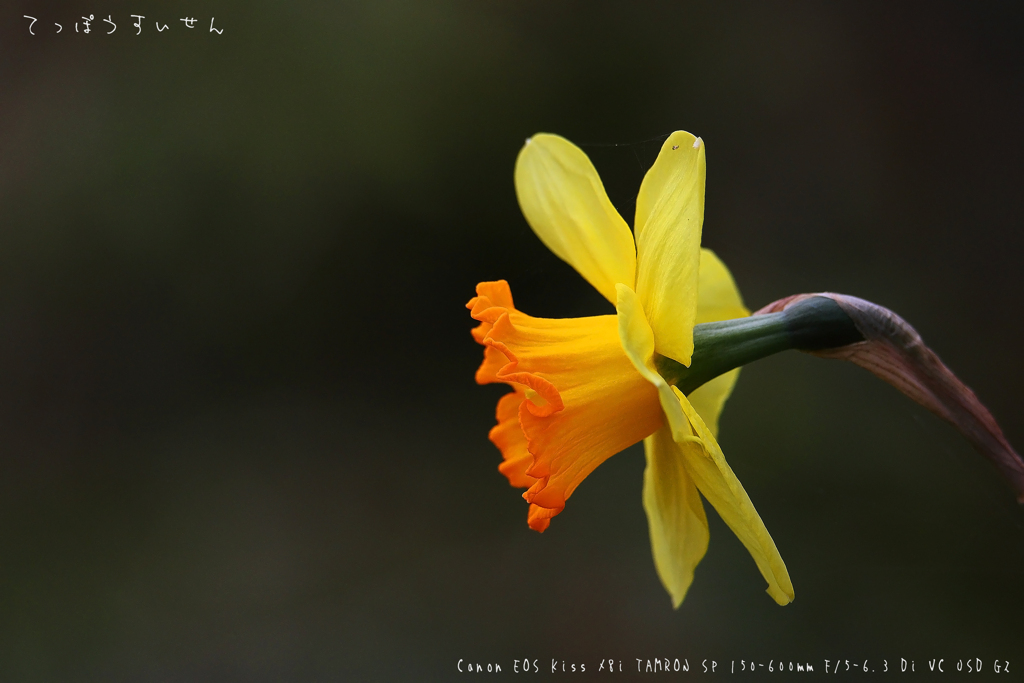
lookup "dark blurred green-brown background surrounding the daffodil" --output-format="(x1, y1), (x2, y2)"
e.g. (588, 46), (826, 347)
(0, 0), (1024, 681)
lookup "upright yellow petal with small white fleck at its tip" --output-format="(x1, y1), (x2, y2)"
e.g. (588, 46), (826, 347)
(635, 131), (706, 366)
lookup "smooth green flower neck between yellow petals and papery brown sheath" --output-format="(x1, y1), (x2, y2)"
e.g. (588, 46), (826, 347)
(654, 297), (864, 395)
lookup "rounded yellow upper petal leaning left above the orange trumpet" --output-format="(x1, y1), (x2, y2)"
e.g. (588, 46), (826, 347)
(515, 133), (636, 303)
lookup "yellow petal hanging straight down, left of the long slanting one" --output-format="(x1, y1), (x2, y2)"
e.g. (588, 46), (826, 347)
(643, 426), (708, 607)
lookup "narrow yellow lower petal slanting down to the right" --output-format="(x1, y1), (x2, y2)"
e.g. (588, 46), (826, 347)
(673, 387), (794, 605)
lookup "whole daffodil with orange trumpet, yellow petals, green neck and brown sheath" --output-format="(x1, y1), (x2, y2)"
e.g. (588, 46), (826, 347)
(467, 132), (1024, 607)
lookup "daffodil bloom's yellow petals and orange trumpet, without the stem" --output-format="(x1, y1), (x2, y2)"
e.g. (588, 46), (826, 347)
(467, 131), (794, 607)
